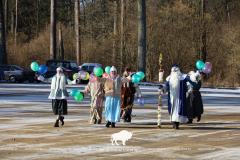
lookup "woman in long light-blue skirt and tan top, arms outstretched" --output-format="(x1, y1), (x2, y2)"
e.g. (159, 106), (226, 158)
(94, 66), (131, 127)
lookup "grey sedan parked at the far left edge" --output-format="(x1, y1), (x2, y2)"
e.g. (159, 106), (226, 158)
(0, 65), (32, 83)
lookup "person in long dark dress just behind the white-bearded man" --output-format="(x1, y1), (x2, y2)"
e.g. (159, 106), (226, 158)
(186, 71), (203, 123)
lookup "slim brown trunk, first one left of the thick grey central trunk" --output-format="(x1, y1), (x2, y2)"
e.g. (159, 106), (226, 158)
(120, 0), (126, 73)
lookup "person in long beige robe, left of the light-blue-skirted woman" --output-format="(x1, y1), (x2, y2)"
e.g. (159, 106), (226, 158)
(82, 70), (105, 124)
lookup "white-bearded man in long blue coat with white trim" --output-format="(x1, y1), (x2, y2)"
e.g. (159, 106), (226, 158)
(159, 65), (201, 129)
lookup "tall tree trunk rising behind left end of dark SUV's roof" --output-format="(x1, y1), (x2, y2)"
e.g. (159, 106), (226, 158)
(50, 0), (57, 59)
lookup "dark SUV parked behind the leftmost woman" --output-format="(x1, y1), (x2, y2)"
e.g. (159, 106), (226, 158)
(45, 59), (80, 80)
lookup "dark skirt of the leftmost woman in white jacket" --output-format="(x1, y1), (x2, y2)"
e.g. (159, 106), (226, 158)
(52, 99), (67, 115)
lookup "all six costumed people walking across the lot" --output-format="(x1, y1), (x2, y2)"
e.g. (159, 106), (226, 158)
(38, 65), (203, 129)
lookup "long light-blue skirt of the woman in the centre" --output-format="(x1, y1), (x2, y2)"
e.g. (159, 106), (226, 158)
(105, 97), (121, 123)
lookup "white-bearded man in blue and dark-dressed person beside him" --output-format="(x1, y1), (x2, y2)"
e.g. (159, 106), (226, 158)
(159, 65), (203, 129)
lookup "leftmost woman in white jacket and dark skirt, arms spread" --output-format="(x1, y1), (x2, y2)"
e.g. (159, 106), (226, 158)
(38, 67), (77, 127)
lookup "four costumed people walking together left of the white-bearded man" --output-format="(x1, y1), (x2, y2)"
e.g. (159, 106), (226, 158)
(38, 66), (141, 127)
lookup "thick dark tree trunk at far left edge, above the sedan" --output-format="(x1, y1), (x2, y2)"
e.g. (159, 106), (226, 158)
(0, 0), (7, 65)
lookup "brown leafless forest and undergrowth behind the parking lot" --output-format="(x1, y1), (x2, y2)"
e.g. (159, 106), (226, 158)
(0, 0), (240, 87)
